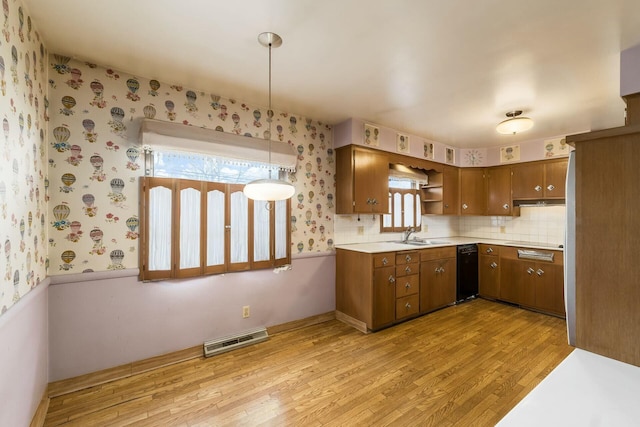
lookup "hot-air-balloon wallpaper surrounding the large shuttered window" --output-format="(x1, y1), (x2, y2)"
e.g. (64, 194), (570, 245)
(47, 55), (335, 275)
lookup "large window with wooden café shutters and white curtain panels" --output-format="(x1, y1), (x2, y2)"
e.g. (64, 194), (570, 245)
(140, 152), (291, 280)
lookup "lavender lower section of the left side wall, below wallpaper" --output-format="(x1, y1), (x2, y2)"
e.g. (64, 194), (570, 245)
(0, 279), (49, 426)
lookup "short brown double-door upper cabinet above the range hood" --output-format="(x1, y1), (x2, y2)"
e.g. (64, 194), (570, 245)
(511, 158), (567, 200)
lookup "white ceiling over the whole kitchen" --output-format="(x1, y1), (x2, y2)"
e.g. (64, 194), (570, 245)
(23, 0), (640, 148)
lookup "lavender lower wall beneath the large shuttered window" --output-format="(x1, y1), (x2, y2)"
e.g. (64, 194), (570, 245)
(49, 255), (335, 381)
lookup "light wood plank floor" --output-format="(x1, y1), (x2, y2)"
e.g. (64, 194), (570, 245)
(45, 300), (572, 426)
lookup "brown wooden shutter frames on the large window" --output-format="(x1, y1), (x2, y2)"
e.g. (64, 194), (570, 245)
(139, 176), (291, 281)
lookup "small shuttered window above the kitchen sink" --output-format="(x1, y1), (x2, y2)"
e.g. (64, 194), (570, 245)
(380, 177), (422, 232)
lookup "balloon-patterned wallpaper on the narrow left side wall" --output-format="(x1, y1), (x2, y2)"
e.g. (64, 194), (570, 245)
(0, 0), (48, 313)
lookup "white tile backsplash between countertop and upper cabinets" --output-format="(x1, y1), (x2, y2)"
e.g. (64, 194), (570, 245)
(334, 206), (566, 244)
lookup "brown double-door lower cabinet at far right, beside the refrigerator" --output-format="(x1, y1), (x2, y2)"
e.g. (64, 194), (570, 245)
(499, 246), (565, 316)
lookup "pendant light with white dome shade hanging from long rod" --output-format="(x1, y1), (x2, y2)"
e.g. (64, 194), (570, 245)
(242, 32), (296, 201)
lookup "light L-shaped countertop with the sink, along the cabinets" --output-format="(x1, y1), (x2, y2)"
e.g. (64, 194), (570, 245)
(336, 237), (562, 253)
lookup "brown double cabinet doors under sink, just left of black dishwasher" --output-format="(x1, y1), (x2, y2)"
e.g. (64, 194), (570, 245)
(420, 258), (456, 313)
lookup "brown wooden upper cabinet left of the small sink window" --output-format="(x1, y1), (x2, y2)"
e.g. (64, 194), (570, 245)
(336, 145), (389, 214)
